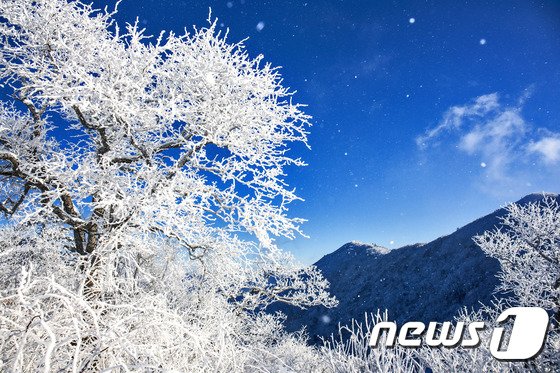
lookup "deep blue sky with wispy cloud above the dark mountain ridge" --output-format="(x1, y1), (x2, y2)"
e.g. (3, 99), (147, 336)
(94, 0), (560, 263)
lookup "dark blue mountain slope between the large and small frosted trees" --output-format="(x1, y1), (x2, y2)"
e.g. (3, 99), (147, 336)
(274, 194), (558, 341)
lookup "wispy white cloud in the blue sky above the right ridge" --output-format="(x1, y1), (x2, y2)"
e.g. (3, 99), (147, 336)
(416, 88), (560, 193)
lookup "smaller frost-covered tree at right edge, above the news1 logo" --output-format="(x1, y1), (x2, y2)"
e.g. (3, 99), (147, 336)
(474, 195), (560, 324)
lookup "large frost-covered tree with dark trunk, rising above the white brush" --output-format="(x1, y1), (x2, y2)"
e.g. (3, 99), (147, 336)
(0, 0), (334, 309)
